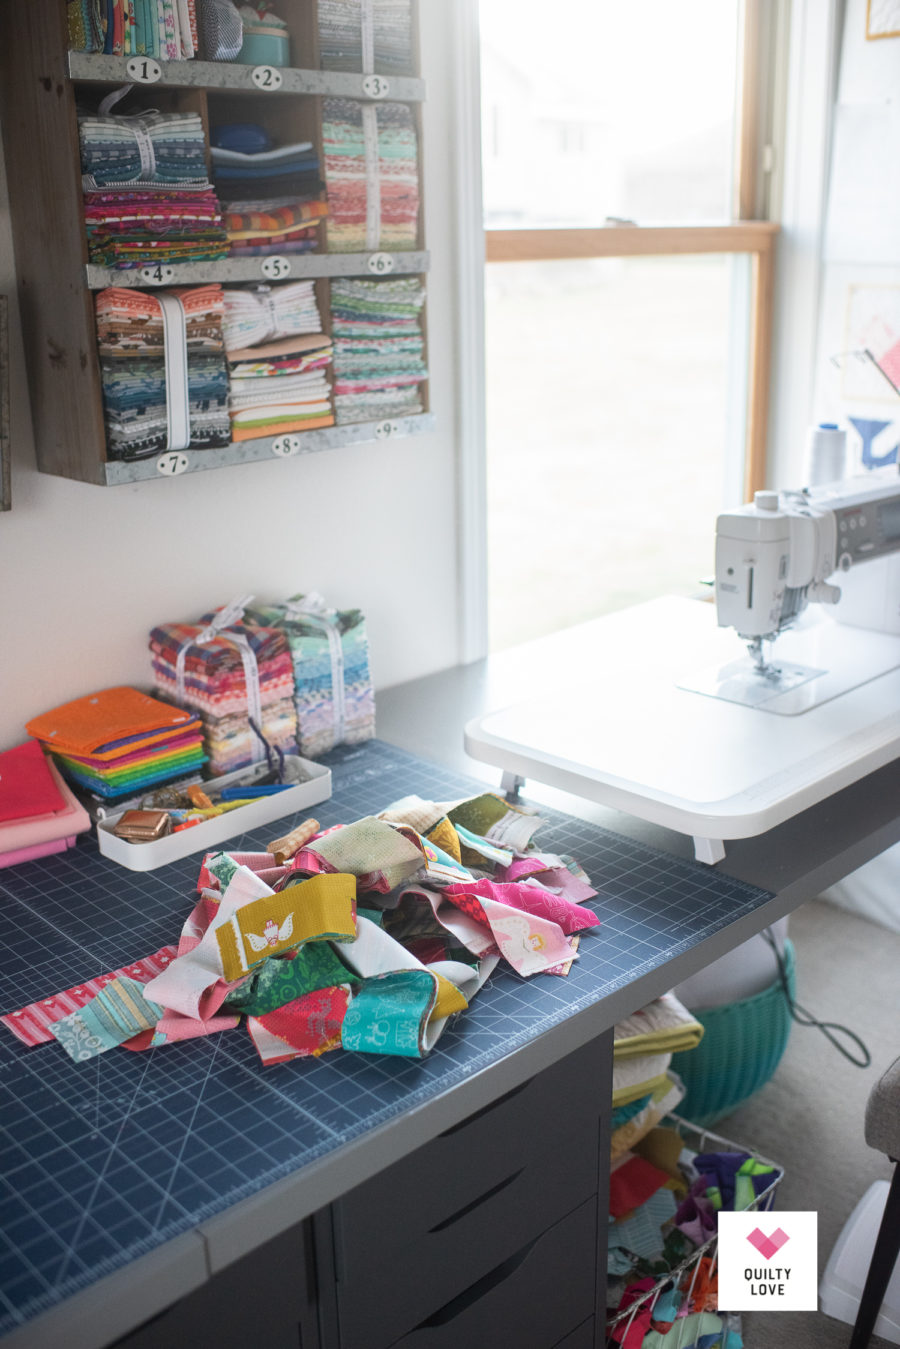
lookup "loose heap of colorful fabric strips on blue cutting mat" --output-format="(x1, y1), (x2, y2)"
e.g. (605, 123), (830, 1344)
(0, 793), (599, 1064)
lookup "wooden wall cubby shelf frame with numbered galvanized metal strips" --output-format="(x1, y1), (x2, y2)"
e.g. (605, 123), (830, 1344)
(0, 0), (433, 487)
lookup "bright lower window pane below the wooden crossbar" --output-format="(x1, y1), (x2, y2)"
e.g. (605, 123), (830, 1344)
(486, 255), (734, 650)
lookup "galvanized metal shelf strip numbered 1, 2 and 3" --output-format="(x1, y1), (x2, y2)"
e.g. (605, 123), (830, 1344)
(66, 51), (425, 103)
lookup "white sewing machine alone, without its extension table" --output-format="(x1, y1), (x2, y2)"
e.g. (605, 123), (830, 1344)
(680, 465), (900, 715)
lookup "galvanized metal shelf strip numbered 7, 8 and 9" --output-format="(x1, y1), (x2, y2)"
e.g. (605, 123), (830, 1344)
(105, 413), (434, 487)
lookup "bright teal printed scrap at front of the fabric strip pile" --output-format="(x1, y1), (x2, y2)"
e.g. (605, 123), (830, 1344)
(340, 970), (437, 1059)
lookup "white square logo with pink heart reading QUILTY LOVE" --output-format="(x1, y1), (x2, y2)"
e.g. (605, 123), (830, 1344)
(719, 1210), (818, 1311)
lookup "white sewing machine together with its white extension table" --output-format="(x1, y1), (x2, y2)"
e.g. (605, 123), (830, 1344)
(466, 468), (900, 862)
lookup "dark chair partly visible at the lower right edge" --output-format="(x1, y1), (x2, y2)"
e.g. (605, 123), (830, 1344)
(849, 1059), (900, 1349)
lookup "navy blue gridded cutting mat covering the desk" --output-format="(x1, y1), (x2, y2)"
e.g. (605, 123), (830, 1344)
(0, 741), (769, 1334)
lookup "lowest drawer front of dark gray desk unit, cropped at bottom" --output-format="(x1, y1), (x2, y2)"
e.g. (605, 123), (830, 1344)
(394, 1198), (598, 1349)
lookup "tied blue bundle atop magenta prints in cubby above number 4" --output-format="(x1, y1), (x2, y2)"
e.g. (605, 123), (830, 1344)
(78, 100), (228, 268)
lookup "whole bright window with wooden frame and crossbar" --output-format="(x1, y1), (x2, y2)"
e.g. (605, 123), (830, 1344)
(480, 0), (777, 649)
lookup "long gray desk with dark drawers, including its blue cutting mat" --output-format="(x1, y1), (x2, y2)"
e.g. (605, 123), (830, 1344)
(0, 623), (900, 1349)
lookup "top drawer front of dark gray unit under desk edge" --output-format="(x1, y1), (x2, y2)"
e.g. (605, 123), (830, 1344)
(333, 1037), (610, 1262)
